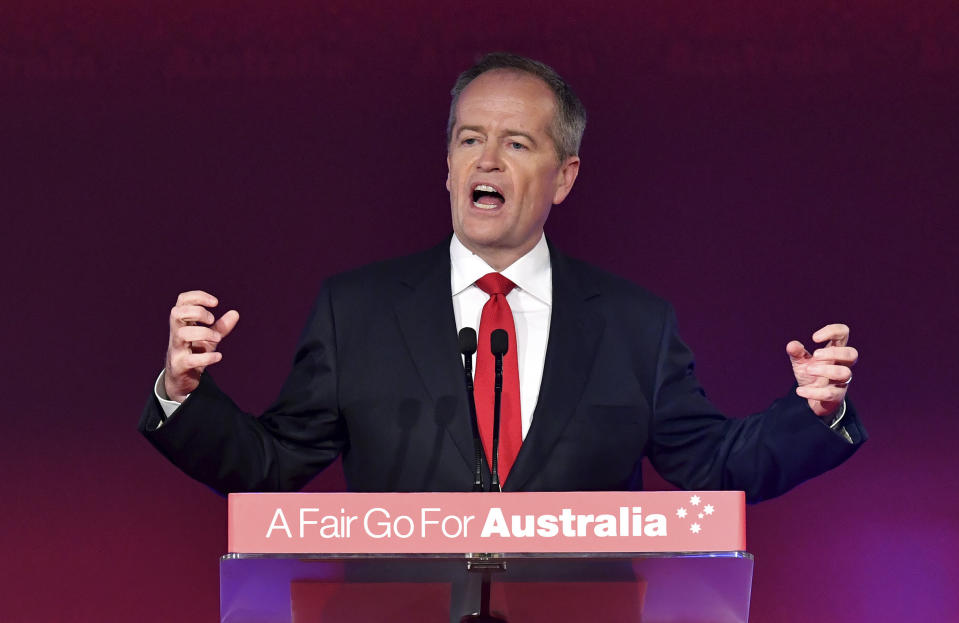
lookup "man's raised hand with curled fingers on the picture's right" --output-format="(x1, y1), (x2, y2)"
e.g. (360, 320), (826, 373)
(786, 324), (859, 417)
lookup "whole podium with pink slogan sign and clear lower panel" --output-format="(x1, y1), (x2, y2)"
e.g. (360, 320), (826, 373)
(220, 491), (753, 623)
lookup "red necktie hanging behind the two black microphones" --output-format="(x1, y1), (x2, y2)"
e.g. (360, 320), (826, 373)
(473, 273), (523, 483)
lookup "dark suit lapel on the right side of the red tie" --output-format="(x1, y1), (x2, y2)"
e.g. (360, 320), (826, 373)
(504, 245), (605, 491)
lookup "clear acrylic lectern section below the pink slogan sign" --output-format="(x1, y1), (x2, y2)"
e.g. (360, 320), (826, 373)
(220, 552), (753, 623)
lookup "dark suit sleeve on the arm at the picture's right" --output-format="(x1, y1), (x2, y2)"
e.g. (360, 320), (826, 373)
(648, 307), (866, 502)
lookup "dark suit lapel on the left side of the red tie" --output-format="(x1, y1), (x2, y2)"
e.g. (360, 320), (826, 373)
(394, 239), (473, 469)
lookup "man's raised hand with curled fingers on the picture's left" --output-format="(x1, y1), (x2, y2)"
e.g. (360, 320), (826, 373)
(163, 290), (240, 402)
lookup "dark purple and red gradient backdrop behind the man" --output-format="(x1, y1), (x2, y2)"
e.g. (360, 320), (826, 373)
(0, 0), (959, 622)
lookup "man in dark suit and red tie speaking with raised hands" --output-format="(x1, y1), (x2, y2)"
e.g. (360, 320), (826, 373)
(140, 54), (866, 501)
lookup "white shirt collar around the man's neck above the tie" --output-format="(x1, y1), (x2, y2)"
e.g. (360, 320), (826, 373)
(450, 234), (553, 305)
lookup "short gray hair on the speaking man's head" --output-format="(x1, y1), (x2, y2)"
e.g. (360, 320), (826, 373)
(446, 52), (586, 161)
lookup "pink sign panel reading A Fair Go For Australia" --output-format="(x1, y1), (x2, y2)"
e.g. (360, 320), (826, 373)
(229, 491), (746, 554)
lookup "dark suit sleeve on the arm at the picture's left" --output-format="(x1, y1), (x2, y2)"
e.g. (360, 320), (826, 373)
(139, 287), (348, 494)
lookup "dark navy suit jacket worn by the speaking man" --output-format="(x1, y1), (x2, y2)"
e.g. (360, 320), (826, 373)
(140, 243), (866, 501)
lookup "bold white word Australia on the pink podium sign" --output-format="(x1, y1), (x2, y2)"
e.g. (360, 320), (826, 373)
(480, 506), (666, 537)
